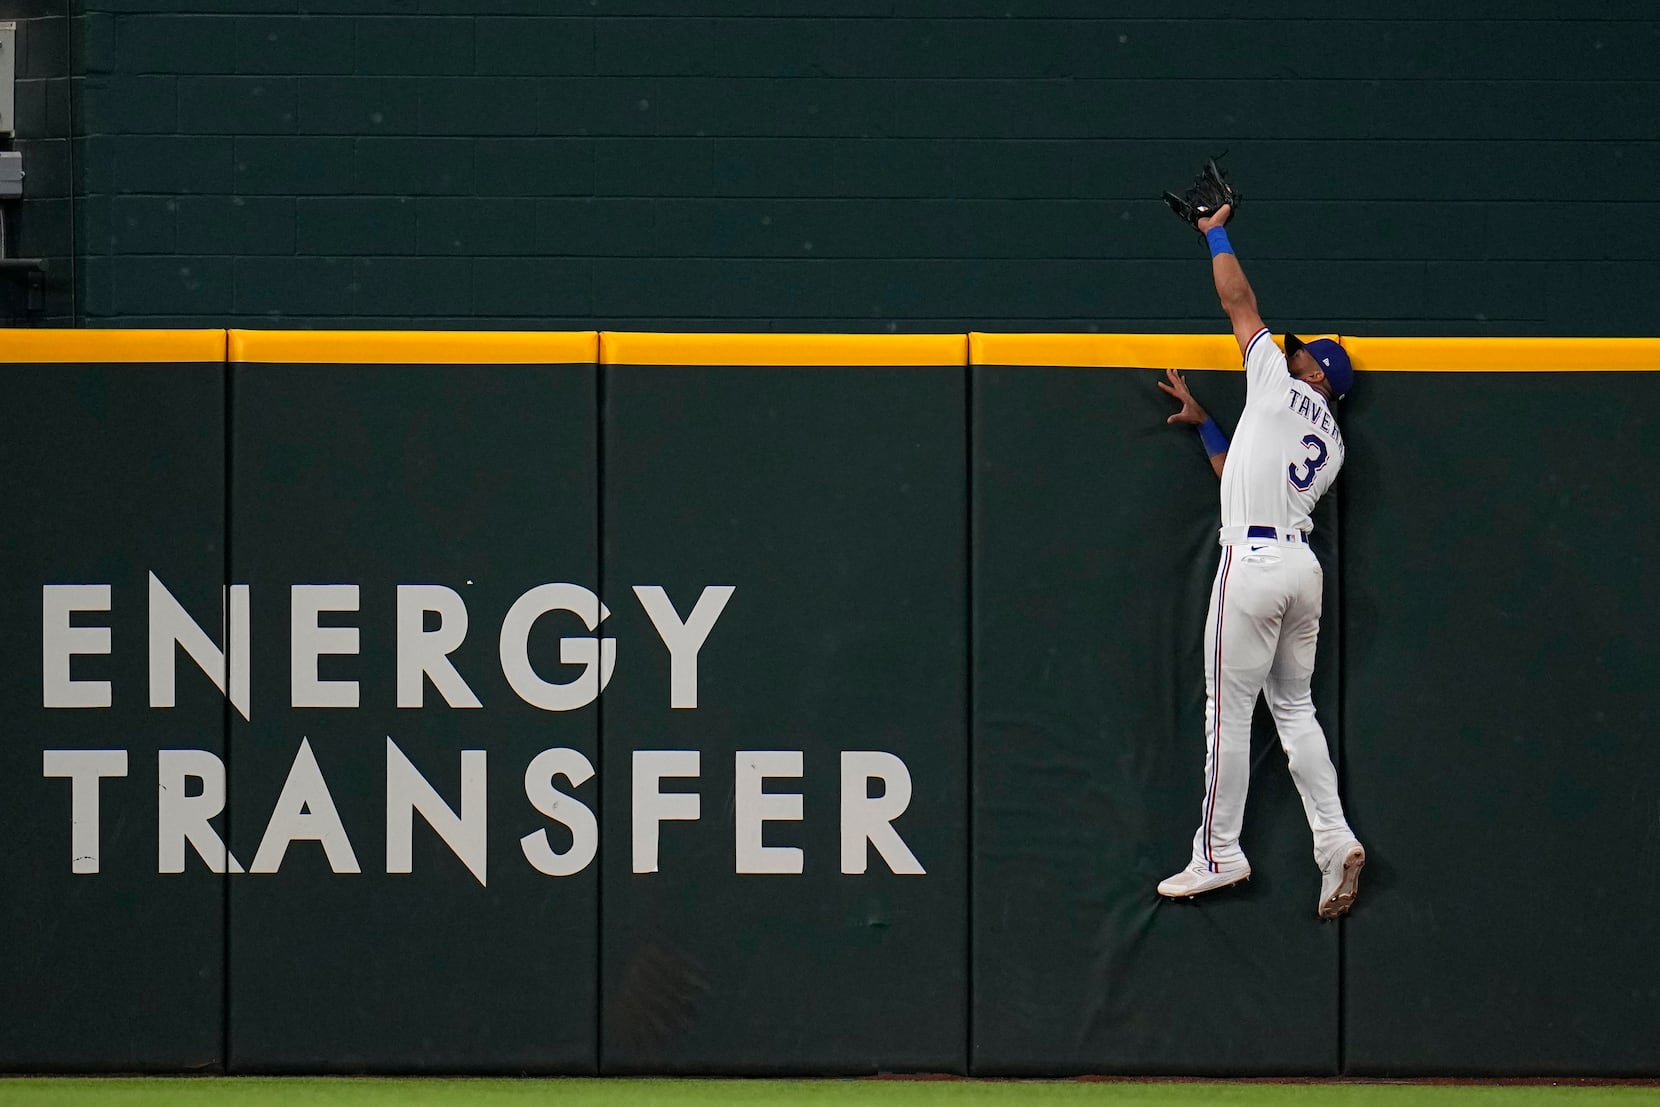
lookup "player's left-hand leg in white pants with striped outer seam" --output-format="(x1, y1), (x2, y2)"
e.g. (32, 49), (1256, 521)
(1159, 546), (1283, 895)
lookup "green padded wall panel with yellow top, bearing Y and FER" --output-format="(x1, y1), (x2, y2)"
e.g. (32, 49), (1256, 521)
(601, 334), (969, 1074)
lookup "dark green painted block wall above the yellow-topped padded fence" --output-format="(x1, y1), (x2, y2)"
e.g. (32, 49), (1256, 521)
(48, 0), (1660, 335)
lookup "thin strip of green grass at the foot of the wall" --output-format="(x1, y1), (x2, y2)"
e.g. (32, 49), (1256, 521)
(0, 1077), (1660, 1107)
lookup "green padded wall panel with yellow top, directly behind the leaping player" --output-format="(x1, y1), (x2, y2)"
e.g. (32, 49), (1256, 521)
(971, 335), (1341, 1075)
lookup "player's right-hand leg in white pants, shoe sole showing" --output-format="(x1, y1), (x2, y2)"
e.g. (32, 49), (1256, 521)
(1263, 554), (1366, 916)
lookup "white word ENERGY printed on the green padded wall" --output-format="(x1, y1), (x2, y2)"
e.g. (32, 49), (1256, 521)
(40, 573), (735, 719)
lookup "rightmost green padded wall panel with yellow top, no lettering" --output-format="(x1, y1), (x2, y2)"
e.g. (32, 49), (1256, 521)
(1341, 339), (1660, 1075)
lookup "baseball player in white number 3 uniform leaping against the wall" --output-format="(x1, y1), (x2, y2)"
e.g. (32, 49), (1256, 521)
(1159, 204), (1366, 918)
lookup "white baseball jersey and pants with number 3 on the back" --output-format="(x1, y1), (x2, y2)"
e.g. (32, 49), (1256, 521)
(1194, 327), (1353, 873)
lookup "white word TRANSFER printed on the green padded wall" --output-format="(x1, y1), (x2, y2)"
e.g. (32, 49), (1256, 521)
(42, 737), (925, 886)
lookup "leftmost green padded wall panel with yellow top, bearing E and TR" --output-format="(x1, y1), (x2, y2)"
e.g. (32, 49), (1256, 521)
(0, 330), (226, 1072)
